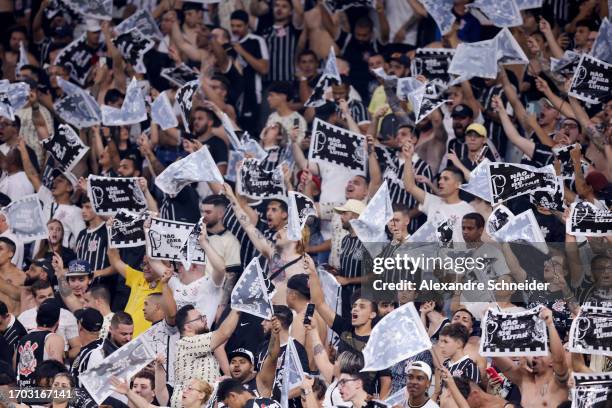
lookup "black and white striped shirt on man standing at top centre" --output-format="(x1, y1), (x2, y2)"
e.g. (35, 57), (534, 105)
(261, 23), (302, 83)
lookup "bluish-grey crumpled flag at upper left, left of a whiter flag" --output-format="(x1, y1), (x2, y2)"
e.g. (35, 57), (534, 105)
(53, 77), (102, 129)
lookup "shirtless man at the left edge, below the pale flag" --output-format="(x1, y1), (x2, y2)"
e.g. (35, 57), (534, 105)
(0, 237), (26, 314)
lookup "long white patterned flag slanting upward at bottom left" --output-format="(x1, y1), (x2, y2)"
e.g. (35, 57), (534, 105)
(79, 337), (155, 404)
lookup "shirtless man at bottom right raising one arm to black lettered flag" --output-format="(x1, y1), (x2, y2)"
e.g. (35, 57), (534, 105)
(493, 308), (569, 408)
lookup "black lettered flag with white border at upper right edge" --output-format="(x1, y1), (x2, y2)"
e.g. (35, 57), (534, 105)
(568, 54), (612, 104)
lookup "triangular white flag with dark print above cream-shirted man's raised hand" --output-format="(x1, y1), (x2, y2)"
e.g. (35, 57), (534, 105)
(231, 258), (272, 320)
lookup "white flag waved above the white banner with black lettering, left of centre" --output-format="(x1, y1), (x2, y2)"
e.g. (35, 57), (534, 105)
(155, 146), (223, 195)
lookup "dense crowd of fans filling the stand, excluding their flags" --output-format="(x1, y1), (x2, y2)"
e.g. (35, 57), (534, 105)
(0, 0), (612, 408)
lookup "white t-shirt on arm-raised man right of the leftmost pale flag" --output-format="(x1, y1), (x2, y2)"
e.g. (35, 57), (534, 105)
(38, 186), (85, 249)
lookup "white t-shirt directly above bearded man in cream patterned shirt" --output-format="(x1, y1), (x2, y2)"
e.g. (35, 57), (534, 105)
(168, 275), (223, 328)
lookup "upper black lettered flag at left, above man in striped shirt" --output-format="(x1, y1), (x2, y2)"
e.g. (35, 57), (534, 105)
(87, 175), (147, 216)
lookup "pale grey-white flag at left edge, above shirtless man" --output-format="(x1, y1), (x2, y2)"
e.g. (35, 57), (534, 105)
(2, 194), (49, 242)
